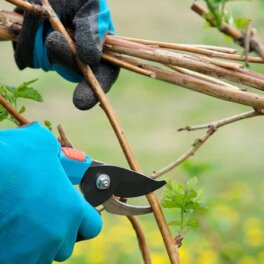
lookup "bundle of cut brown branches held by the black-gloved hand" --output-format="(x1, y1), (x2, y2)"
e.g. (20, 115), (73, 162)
(0, 11), (264, 109)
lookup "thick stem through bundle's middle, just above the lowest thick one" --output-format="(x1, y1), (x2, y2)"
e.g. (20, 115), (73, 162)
(105, 37), (264, 90)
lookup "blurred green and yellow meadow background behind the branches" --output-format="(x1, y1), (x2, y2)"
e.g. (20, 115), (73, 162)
(0, 0), (264, 264)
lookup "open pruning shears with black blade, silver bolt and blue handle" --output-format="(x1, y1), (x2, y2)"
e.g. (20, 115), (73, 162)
(60, 147), (166, 216)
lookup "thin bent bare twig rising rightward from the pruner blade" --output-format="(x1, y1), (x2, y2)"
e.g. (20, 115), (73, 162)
(152, 111), (263, 179)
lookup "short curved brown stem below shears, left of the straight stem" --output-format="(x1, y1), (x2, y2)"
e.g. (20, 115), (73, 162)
(127, 216), (152, 264)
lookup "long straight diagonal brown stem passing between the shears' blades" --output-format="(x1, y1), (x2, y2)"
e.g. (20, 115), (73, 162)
(4, 0), (180, 264)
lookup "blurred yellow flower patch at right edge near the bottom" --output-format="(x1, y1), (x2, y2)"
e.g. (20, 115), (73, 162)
(243, 217), (264, 247)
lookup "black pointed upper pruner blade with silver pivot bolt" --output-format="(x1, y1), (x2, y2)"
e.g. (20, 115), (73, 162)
(80, 164), (166, 210)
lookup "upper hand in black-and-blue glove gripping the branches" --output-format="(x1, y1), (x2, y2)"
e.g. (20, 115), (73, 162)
(14, 0), (119, 110)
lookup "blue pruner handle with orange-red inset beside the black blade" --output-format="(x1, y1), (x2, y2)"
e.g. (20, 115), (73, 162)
(60, 147), (93, 185)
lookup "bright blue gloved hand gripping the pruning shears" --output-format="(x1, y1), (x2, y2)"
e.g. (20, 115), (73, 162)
(0, 123), (102, 264)
